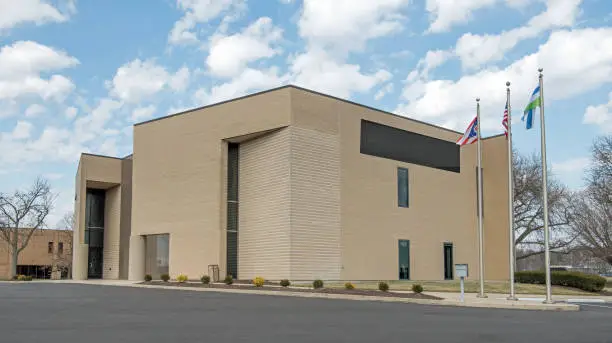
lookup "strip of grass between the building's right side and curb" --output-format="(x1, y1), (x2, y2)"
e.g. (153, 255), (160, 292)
(296, 280), (610, 295)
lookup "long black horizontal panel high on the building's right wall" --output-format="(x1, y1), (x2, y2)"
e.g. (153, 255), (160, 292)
(360, 120), (461, 173)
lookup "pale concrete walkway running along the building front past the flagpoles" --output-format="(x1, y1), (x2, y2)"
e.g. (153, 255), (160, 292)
(17, 280), (596, 311)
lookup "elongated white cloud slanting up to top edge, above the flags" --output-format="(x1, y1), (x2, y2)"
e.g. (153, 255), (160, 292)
(455, 0), (582, 69)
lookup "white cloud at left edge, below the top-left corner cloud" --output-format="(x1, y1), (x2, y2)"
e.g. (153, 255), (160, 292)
(0, 41), (79, 101)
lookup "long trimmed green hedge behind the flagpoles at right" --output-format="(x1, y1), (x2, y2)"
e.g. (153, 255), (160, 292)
(514, 271), (606, 292)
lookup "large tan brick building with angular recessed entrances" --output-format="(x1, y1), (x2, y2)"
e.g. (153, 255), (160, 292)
(73, 86), (509, 280)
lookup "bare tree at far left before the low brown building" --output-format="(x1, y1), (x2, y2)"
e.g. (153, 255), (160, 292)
(0, 178), (54, 277)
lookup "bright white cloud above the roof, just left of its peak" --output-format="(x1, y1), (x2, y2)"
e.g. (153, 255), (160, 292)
(206, 17), (282, 77)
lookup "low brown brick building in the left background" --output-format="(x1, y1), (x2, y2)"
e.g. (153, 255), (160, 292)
(0, 230), (73, 279)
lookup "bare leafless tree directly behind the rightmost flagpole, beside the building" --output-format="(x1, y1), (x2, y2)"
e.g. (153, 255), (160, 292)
(513, 152), (576, 260)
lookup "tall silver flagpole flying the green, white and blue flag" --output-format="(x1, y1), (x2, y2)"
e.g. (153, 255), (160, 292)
(538, 68), (552, 304)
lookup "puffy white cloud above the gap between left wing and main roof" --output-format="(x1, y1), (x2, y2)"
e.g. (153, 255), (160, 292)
(107, 59), (189, 103)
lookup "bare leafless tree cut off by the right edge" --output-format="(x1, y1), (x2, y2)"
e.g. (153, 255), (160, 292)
(574, 135), (612, 265)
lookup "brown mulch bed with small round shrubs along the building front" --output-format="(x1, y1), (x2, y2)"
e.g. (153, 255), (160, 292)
(140, 281), (442, 300)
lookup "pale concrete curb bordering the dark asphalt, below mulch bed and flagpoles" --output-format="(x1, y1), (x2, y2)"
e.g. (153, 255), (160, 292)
(110, 284), (580, 311)
